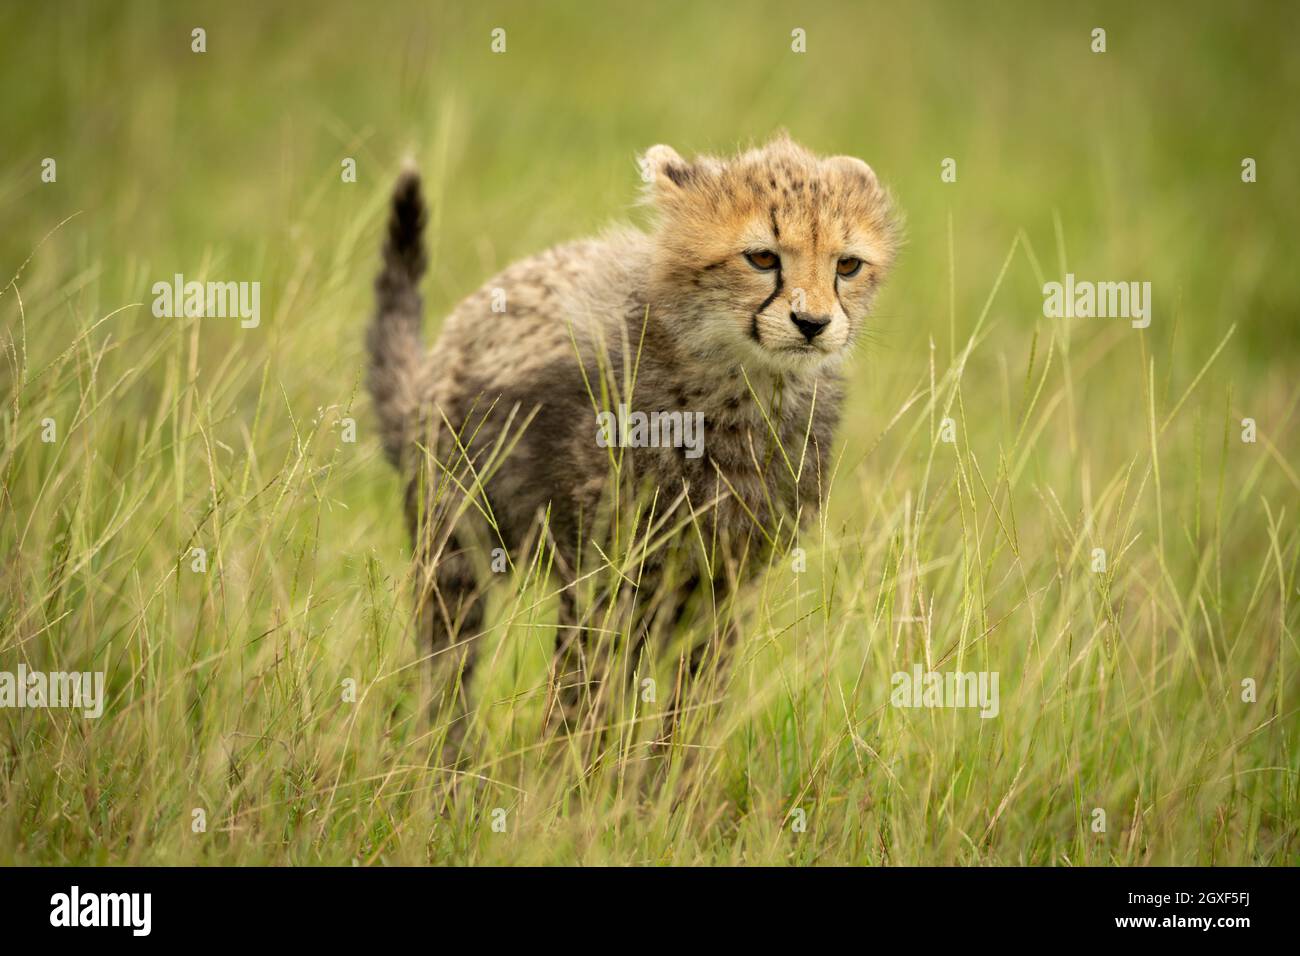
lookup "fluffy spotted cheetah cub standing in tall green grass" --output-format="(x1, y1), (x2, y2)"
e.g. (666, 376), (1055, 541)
(368, 135), (898, 753)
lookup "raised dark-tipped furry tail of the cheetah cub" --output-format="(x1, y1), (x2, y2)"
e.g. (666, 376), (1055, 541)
(365, 165), (428, 464)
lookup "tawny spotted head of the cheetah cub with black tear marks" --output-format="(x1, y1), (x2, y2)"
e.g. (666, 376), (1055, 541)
(641, 135), (898, 375)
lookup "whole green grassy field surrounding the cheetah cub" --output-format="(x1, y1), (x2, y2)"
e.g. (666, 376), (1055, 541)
(0, 1), (1300, 865)
